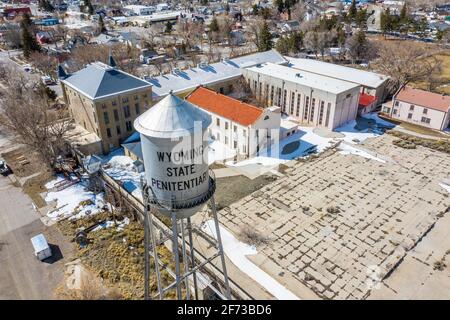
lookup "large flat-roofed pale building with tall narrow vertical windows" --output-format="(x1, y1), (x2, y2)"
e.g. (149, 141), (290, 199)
(243, 63), (360, 130)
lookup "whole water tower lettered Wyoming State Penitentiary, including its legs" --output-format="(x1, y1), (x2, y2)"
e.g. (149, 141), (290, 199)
(134, 93), (230, 299)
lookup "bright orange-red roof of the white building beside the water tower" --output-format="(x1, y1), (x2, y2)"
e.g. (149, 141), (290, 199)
(187, 87), (263, 126)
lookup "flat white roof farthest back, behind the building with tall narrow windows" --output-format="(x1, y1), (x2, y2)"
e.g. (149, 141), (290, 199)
(285, 57), (388, 88)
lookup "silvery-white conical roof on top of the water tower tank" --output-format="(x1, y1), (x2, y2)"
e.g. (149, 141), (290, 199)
(134, 93), (211, 138)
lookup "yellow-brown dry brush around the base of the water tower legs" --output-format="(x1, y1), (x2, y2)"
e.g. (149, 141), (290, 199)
(59, 212), (179, 299)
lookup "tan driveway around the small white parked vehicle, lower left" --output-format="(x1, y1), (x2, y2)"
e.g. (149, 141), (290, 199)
(0, 172), (73, 299)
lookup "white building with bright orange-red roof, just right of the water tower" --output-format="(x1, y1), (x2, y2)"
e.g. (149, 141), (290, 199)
(186, 87), (281, 158)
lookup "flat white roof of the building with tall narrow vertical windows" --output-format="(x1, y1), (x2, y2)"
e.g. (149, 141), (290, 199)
(247, 63), (359, 94)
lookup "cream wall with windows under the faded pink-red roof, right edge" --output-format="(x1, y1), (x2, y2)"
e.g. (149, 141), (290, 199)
(391, 100), (449, 130)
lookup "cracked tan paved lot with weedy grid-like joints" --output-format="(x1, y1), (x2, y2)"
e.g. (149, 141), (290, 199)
(221, 135), (450, 299)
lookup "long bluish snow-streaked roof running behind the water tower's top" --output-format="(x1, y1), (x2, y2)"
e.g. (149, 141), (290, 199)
(148, 50), (287, 99)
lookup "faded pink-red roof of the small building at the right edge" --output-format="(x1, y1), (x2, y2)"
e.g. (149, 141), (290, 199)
(395, 87), (450, 112)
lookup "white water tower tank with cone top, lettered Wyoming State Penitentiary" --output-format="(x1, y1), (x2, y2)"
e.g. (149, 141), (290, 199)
(134, 93), (215, 218)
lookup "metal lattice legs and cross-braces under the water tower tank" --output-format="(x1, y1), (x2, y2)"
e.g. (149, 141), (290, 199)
(144, 197), (231, 300)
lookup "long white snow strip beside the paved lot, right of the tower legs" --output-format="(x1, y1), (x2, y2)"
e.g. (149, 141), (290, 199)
(202, 220), (299, 300)
